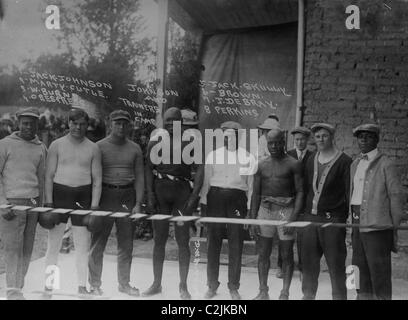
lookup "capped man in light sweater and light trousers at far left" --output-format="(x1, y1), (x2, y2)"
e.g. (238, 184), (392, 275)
(0, 108), (47, 300)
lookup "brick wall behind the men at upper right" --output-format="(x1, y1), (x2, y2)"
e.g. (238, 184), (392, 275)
(304, 0), (408, 186)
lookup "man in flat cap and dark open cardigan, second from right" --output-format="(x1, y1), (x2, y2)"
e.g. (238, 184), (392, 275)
(301, 123), (351, 300)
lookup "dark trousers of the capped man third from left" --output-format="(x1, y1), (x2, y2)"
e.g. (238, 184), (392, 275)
(88, 187), (136, 287)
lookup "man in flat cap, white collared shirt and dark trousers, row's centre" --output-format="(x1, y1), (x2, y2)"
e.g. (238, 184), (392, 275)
(201, 121), (256, 300)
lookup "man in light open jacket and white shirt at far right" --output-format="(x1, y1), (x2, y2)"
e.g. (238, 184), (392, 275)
(350, 124), (403, 300)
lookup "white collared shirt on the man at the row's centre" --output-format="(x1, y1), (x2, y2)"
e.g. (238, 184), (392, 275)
(200, 147), (257, 208)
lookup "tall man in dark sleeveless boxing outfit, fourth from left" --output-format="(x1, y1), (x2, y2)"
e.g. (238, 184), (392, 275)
(142, 107), (204, 300)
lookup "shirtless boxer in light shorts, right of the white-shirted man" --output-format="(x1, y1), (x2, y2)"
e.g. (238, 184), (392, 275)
(250, 128), (303, 300)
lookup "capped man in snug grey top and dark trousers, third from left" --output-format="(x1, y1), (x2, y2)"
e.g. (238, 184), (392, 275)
(88, 110), (144, 296)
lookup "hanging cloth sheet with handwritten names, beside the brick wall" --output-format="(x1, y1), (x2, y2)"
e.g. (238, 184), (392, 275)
(199, 23), (297, 130)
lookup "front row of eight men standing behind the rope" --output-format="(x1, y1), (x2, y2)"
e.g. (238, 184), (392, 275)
(0, 108), (402, 299)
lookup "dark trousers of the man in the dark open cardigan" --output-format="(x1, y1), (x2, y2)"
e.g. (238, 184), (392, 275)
(302, 214), (347, 300)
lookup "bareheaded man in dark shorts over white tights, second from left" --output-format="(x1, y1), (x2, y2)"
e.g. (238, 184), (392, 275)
(45, 109), (102, 294)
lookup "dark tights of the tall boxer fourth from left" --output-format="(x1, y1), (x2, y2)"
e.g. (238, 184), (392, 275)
(153, 179), (191, 287)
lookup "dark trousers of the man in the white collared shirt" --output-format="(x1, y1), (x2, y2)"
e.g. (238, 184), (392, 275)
(207, 187), (247, 290)
